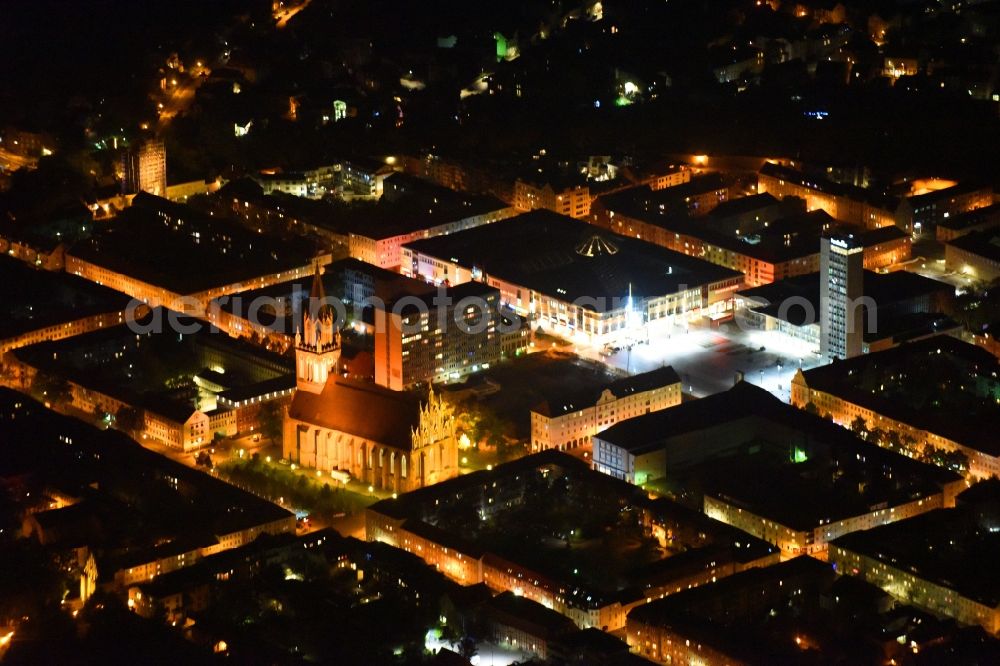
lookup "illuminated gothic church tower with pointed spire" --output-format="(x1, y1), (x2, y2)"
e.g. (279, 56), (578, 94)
(295, 265), (340, 393)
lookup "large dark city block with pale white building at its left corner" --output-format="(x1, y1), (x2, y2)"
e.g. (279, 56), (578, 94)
(593, 382), (965, 557)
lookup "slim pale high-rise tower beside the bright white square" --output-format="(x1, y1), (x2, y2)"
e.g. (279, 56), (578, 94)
(819, 234), (865, 359)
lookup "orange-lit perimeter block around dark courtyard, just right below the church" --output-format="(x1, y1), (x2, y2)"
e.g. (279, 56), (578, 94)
(365, 451), (779, 631)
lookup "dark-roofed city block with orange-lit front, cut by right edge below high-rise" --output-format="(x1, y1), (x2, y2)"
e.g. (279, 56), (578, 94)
(791, 336), (1000, 477)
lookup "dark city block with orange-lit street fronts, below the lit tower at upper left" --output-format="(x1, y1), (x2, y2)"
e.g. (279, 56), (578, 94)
(66, 192), (320, 315)
